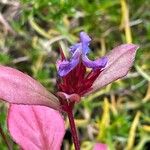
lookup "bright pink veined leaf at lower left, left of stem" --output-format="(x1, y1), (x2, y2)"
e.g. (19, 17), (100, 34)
(7, 104), (65, 150)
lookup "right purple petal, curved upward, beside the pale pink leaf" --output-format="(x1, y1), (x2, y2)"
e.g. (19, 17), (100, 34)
(82, 56), (107, 69)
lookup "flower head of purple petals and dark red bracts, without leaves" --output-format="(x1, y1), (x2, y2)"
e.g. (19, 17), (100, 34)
(57, 32), (108, 96)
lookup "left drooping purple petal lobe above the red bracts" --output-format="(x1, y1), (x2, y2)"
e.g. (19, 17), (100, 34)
(58, 50), (81, 76)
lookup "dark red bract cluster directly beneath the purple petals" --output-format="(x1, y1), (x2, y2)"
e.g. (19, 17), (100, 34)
(57, 62), (101, 96)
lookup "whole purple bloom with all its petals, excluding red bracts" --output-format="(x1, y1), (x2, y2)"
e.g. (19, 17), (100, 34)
(58, 32), (107, 77)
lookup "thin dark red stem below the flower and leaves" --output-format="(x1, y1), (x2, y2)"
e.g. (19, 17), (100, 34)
(67, 109), (80, 150)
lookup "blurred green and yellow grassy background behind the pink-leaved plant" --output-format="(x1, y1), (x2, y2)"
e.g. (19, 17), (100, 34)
(0, 0), (150, 150)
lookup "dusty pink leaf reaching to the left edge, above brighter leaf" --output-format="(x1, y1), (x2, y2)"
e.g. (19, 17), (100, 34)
(0, 66), (60, 109)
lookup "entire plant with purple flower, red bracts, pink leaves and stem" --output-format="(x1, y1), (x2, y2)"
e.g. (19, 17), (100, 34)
(0, 32), (138, 150)
